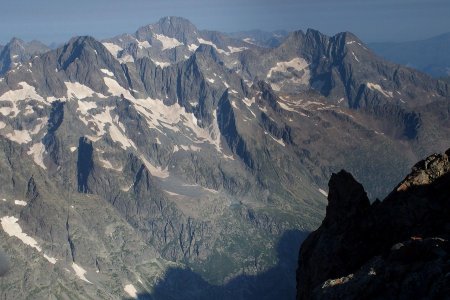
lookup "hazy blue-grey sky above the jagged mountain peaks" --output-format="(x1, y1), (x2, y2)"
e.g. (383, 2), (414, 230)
(0, 0), (450, 44)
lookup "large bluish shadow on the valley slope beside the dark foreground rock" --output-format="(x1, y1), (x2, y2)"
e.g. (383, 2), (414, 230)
(126, 230), (309, 300)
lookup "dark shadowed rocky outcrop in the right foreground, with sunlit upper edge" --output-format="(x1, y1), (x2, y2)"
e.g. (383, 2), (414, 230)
(297, 149), (450, 299)
